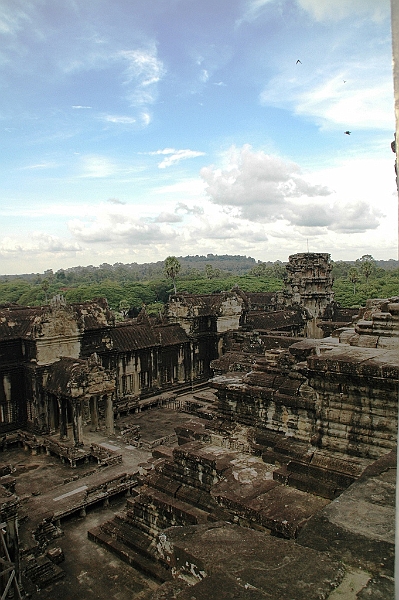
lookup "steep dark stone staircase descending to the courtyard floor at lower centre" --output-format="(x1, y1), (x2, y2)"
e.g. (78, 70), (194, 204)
(88, 448), (230, 582)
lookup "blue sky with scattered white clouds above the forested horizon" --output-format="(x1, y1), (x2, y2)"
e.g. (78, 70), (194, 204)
(0, 0), (398, 274)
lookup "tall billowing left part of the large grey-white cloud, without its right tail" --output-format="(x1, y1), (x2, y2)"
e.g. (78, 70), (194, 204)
(200, 145), (332, 222)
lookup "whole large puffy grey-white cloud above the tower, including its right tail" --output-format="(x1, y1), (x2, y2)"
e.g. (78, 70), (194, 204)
(201, 146), (383, 235)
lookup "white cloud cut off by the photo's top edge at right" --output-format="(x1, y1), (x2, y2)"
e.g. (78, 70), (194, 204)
(297, 0), (390, 21)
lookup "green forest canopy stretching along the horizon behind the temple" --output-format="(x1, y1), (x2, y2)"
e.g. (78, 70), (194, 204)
(0, 254), (399, 312)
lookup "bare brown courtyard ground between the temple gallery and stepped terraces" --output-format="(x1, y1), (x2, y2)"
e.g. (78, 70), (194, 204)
(0, 395), (209, 600)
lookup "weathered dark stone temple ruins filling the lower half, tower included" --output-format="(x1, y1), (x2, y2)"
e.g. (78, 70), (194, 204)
(0, 253), (399, 600)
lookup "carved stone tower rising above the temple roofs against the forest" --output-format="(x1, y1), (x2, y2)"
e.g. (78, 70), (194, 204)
(284, 252), (334, 338)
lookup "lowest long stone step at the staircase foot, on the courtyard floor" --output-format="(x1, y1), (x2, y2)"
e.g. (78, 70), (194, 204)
(88, 526), (172, 583)
